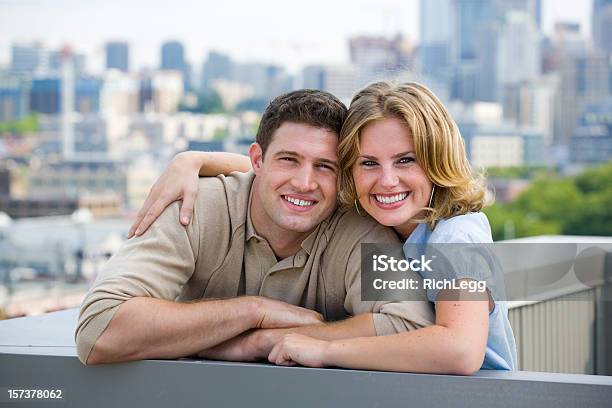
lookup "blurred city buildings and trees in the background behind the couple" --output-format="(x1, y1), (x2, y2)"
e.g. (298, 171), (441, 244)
(0, 0), (612, 318)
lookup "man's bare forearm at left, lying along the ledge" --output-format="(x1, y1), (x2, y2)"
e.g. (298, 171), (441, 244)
(87, 297), (257, 364)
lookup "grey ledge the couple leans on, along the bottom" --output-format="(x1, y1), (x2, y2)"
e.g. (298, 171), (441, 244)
(0, 310), (612, 408)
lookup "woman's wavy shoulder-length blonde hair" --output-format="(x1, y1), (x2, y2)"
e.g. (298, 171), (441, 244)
(338, 81), (485, 228)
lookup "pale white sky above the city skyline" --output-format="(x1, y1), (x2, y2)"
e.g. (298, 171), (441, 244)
(0, 0), (592, 72)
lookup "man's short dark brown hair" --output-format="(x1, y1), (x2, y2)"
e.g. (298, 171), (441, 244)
(255, 89), (347, 154)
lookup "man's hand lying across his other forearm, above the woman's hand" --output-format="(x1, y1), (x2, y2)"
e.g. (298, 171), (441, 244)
(255, 296), (324, 329)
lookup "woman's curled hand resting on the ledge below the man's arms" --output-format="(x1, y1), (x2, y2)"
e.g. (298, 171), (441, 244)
(268, 333), (330, 368)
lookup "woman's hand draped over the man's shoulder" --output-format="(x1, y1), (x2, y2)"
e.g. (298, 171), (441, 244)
(128, 152), (203, 238)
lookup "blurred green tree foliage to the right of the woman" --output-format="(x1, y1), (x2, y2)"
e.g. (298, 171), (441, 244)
(485, 163), (612, 240)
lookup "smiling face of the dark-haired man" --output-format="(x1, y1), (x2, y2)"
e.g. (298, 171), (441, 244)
(249, 122), (338, 233)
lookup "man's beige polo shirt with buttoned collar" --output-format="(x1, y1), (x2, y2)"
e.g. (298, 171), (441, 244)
(75, 172), (434, 362)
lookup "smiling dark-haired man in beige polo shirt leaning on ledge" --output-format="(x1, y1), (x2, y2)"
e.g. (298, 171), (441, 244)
(76, 90), (433, 364)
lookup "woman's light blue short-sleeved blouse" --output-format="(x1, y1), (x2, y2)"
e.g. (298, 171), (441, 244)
(404, 213), (517, 370)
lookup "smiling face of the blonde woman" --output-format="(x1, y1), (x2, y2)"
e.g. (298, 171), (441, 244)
(353, 118), (433, 237)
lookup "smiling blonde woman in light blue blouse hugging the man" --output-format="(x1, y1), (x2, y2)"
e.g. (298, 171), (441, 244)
(130, 82), (516, 374)
